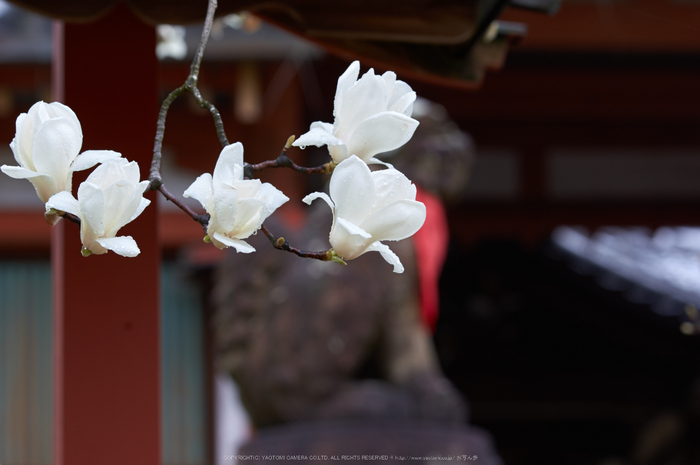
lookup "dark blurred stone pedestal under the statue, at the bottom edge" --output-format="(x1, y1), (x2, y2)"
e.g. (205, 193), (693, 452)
(238, 418), (502, 465)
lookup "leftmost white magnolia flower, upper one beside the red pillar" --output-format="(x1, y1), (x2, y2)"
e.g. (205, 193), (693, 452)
(0, 102), (119, 203)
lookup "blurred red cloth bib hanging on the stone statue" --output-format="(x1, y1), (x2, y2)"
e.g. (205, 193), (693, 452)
(413, 188), (450, 332)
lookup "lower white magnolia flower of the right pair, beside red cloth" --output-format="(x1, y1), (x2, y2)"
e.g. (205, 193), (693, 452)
(304, 156), (425, 273)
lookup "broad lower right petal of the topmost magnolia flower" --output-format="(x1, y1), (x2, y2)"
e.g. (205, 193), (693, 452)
(346, 111), (418, 160)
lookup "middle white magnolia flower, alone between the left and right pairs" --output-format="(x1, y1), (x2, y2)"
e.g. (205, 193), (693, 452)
(184, 142), (289, 253)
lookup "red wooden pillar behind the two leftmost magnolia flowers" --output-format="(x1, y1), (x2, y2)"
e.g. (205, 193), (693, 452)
(52, 4), (160, 465)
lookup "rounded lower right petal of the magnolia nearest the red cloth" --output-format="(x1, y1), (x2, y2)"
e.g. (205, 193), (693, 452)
(361, 200), (425, 241)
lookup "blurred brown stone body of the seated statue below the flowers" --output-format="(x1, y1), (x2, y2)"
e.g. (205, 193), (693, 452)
(215, 210), (465, 427)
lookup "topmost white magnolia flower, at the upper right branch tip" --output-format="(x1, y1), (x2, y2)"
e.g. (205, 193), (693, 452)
(293, 61), (418, 163)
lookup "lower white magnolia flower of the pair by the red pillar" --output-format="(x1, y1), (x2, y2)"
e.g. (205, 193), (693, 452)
(46, 154), (151, 257)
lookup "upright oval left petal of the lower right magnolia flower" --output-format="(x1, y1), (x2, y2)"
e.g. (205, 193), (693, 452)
(329, 155), (374, 224)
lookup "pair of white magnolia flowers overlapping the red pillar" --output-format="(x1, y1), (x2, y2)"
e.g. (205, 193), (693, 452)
(0, 102), (150, 257)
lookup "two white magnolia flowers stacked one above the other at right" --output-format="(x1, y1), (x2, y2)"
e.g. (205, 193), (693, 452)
(294, 61), (425, 273)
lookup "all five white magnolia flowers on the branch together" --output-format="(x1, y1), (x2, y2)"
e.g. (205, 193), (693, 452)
(1, 61), (425, 273)
